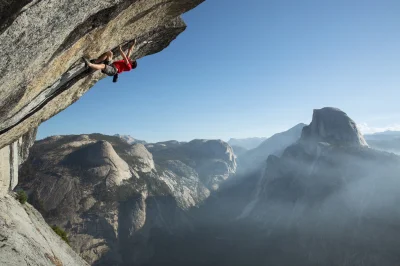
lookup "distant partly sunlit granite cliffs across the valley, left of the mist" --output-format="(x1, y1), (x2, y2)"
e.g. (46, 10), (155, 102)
(20, 134), (236, 265)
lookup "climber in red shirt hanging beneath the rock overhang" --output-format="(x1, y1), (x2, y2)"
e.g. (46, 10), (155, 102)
(83, 40), (137, 82)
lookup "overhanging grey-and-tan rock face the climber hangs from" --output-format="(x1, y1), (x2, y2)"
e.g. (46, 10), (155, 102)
(0, 0), (203, 194)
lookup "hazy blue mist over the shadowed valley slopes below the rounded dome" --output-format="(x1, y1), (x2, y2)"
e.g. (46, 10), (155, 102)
(143, 140), (400, 266)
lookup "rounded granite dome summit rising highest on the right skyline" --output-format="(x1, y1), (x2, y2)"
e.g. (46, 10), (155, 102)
(301, 107), (368, 147)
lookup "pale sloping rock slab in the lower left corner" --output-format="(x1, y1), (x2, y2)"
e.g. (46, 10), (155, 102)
(0, 195), (88, 266)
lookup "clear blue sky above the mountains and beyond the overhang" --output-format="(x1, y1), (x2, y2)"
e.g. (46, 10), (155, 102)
(38, 0), (400, 142)
